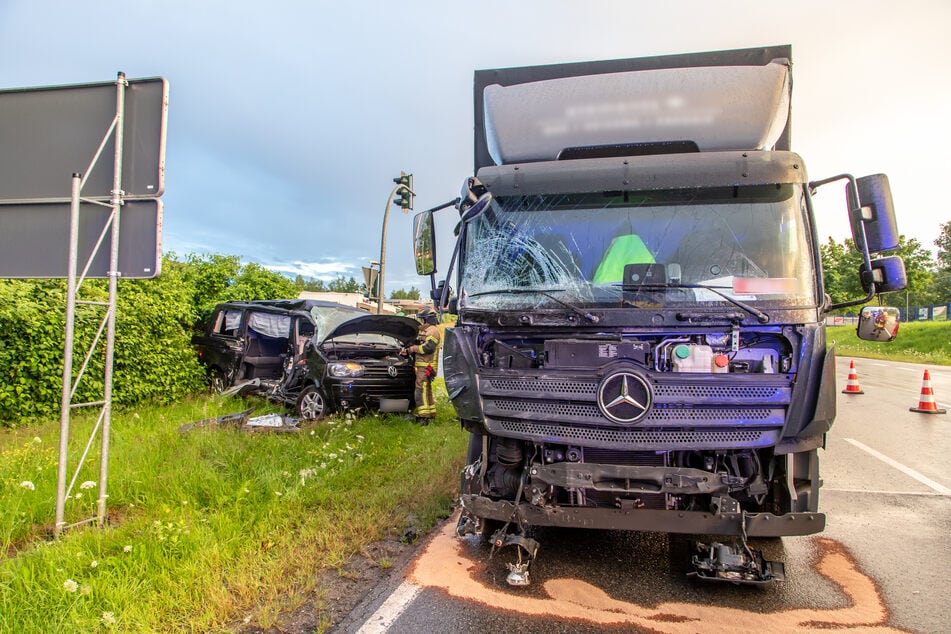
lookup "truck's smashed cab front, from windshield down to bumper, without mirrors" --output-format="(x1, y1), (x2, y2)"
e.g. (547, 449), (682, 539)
(444, 153), (835, 584)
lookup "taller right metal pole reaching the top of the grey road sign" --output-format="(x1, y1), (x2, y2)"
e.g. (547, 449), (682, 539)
(97, 72), (127, 528)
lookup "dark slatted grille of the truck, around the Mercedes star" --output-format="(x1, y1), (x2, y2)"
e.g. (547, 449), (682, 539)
(479, 371), (792, 451)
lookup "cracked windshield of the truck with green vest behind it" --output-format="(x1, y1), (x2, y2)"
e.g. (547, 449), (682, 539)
(462, 185), (815, 310)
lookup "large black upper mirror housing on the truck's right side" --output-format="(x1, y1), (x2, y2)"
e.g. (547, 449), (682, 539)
(845, 174), (898, 253)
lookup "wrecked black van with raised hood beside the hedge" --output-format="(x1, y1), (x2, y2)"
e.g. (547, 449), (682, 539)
(192, 299), (418, 419)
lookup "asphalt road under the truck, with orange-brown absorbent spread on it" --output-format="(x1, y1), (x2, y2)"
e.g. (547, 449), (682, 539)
(337, 357), (951, 634)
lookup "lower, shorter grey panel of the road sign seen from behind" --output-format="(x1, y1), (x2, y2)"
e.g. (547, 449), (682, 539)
(0, 199), (162, 279)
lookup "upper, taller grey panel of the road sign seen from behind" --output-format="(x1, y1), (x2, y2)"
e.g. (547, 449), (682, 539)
(0, 77), (168, 204)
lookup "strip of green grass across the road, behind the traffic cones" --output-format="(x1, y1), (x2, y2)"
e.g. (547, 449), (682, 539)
(826, 321), (951, 365)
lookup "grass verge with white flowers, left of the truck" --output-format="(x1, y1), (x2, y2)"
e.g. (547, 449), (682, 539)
(0, 382), (466, 632)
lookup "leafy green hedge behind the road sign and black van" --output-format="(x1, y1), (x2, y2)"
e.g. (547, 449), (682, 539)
(0, 255), (297, 427)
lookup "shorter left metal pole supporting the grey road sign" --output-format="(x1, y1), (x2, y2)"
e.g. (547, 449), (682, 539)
(53, 174), (82, 537)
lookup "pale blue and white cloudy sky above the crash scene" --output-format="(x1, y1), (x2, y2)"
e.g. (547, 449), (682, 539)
(0, 0), (951, 294)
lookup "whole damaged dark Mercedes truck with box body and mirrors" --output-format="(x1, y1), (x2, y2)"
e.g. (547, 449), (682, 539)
(414, 46), (906, 585)
